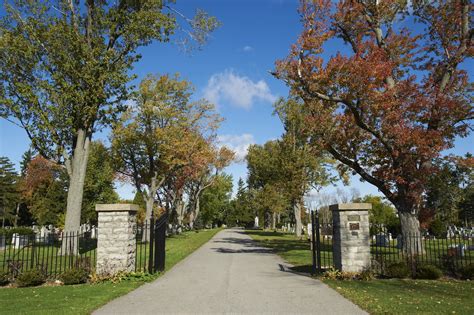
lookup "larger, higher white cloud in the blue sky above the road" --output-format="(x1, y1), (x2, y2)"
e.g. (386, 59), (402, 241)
(204, 70), (276, 109)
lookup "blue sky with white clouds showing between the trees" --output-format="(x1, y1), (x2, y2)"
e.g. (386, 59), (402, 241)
(0, 0), (474, 204)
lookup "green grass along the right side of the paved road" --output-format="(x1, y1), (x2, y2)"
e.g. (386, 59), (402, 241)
(246, 231), (474, 314)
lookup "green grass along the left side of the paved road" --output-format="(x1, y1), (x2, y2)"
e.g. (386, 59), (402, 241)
(0, 229), (220, 314)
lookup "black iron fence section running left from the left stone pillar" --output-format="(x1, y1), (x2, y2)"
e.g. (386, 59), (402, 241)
(0, 232), (97, 276)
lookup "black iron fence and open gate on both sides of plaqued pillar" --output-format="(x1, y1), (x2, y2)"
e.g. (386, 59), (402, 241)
(311, 213), (474, 274)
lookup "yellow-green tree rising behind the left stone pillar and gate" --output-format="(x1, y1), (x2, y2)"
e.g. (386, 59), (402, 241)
(112, 75), (220, 230)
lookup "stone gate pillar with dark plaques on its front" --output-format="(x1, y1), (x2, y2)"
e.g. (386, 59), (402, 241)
(329, 203), (372, 272)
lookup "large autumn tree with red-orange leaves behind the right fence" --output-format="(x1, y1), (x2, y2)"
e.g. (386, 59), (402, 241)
(275, 0), (474, 253)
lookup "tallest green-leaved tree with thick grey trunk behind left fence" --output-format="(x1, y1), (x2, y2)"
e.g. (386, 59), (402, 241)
(0, 0), (219, 238)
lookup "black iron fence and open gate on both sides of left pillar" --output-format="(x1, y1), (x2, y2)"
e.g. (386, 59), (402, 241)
(0, 214), (168, 277)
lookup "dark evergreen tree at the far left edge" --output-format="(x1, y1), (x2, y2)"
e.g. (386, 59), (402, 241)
(0, 156), (20, 227)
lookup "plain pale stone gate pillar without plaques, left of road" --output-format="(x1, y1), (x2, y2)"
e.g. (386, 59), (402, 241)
(95, 204), (138, 274)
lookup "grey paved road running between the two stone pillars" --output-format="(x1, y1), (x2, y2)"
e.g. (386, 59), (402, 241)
(94, 229), (365, 315)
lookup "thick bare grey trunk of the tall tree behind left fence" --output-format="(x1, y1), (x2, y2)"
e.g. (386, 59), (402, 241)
(62, 129), (91, 255)
